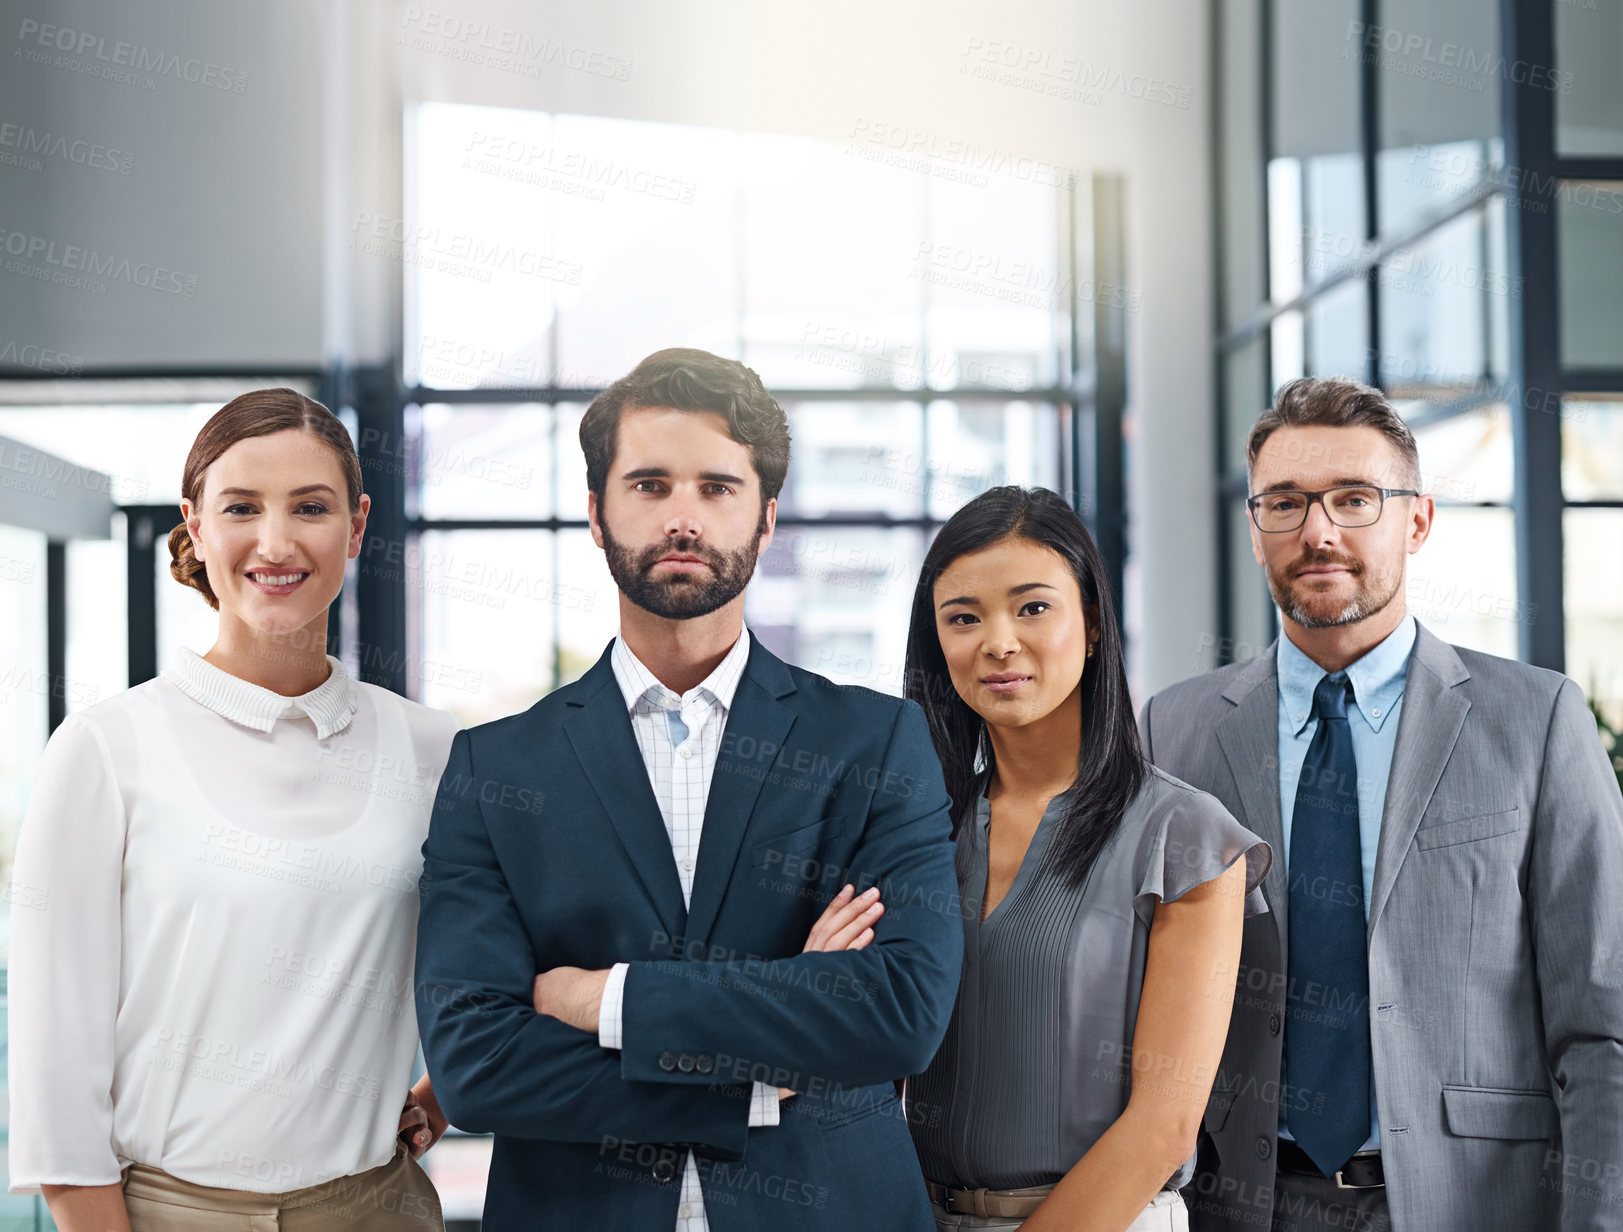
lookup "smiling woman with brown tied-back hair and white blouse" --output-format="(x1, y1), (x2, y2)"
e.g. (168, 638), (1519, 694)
(10, 390), (454, 1232)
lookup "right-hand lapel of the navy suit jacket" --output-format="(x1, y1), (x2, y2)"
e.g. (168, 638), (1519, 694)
(685, 638), (795, 941)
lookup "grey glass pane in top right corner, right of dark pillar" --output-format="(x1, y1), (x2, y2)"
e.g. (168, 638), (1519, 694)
(1555, 0), (1623, 157)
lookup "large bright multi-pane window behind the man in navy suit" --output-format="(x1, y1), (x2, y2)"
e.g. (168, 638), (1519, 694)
(402, 104), (1090, 722)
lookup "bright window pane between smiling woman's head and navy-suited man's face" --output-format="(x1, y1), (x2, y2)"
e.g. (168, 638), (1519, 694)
(406, 531), (561, 727)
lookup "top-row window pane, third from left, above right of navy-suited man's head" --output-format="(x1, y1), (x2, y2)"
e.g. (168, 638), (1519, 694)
(740, 133), (921, 390)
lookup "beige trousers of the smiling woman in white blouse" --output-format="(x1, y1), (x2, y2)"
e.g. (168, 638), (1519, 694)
(123, 1146), (445, 1232)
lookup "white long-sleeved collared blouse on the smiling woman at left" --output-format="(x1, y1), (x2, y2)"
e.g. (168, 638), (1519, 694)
(10, 651), (456, 1193)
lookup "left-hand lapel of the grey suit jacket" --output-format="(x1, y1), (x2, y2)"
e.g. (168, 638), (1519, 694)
(1217, 641), (1290, 946)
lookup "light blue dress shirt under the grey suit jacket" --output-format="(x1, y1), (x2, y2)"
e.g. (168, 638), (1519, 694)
(1279, 615), (1415, 1151)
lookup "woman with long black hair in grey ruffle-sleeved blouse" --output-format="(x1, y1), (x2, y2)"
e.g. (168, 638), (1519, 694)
(907, 487), (1271, 1232)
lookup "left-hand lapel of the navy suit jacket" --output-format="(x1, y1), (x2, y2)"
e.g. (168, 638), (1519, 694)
(563, 651), (688, 937)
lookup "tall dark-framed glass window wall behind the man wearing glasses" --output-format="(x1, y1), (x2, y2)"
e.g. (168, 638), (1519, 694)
(1212, 0), (1603, 675)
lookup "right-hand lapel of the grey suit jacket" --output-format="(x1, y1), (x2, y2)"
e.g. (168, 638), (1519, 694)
(1370, 623), (1470, 937)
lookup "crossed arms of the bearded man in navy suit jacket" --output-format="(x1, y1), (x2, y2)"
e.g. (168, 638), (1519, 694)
(417, 708), (962, 1157)
